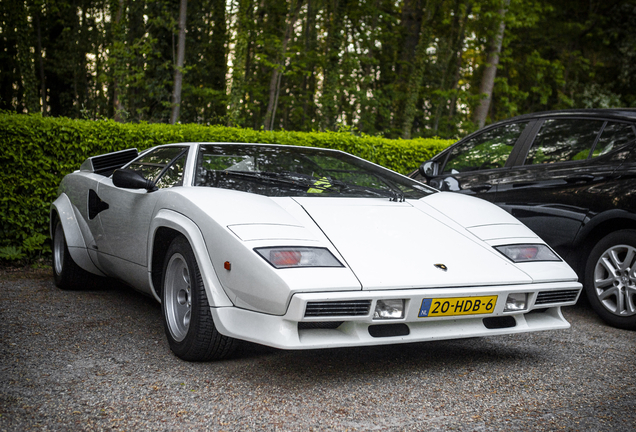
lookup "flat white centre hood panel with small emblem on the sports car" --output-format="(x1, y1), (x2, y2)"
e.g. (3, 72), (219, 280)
(294, 198), (538, 290)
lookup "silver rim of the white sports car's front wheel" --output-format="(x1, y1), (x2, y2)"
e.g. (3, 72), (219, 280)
(164, 253), (192, 342)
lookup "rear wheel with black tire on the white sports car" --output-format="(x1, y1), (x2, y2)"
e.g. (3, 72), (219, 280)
(51, 220), (97, 290)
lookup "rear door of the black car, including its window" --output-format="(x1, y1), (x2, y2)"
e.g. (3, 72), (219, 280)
(497, 118), (633, 257)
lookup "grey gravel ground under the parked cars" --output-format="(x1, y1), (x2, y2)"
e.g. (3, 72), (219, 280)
(0, 269), (636, 431)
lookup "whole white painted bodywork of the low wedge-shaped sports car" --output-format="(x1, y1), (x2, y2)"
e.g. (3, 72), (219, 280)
(51, 143), (581, 349)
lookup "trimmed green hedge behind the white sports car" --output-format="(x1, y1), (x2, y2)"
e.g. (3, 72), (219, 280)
(0, 113), (451, 260)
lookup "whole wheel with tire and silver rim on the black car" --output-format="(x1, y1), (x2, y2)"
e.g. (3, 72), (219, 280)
(584, 230), (636, 330)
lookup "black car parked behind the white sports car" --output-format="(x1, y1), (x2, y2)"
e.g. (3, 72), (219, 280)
(411, 109), (636, 330)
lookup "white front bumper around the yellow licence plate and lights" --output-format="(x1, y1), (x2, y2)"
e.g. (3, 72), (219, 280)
(211, 282), (581, 349)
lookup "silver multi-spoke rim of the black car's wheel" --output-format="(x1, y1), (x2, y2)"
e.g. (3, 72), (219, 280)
(594, 245), (636, 317)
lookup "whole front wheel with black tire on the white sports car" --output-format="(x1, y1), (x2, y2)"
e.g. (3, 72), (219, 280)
(161, 236), (238, 361)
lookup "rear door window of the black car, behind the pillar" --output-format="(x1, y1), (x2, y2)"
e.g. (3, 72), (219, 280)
(525, 119), (603, 165)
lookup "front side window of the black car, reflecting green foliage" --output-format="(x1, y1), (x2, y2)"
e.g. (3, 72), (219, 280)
(442, 123), (527, 173)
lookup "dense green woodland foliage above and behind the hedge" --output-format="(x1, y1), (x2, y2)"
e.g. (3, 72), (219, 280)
(0, 0), (636, 138)
